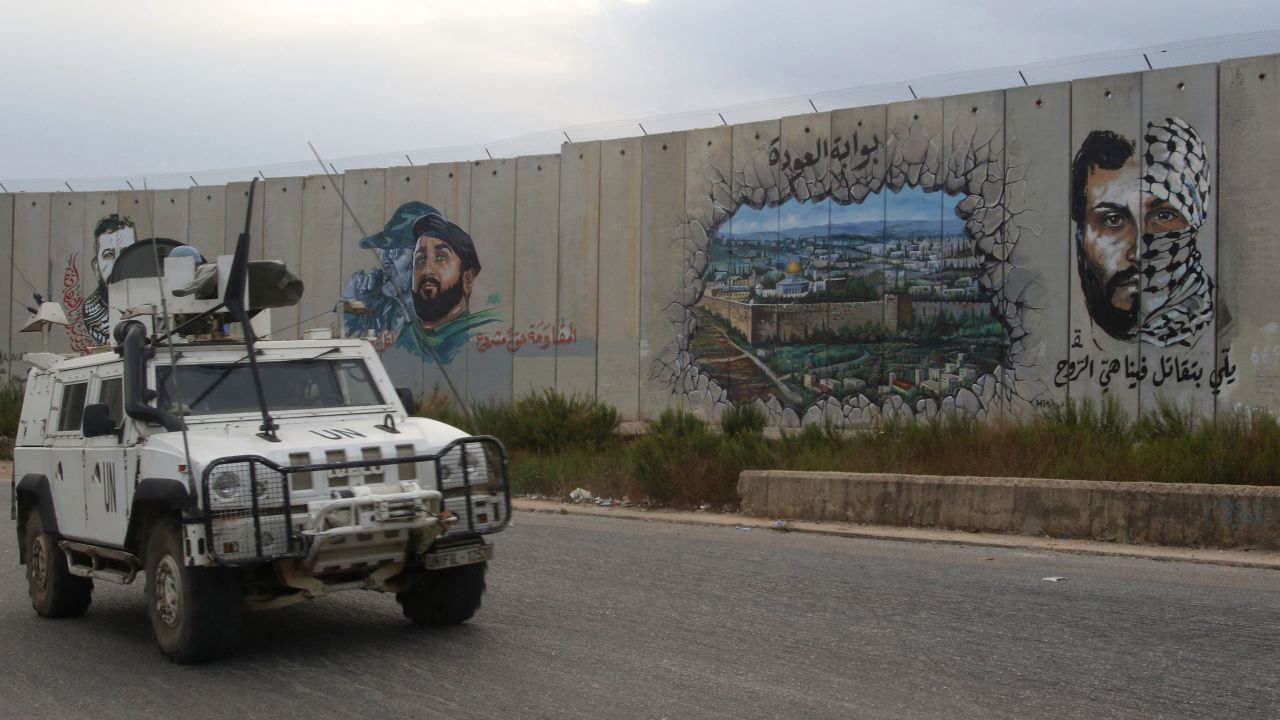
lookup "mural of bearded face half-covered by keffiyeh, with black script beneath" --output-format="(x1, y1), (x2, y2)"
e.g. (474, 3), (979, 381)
(1055, 118), (1236, 395)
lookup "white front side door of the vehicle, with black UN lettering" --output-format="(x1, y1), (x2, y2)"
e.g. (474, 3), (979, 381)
(83, 364), (133, 547)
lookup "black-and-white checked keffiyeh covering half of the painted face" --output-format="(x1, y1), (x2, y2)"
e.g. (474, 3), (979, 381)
(1139, 118), (1213, 347)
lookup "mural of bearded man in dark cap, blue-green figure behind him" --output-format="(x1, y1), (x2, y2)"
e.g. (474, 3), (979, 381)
(343, 201), (500, 364)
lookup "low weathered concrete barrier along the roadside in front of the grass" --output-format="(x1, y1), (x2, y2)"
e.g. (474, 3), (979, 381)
(737, 470), (1280, 550)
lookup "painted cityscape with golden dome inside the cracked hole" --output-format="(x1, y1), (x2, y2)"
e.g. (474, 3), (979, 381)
(691, 187), (1005, 407)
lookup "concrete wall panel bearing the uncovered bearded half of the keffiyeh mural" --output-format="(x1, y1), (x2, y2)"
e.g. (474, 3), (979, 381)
(1066, 73), (1142, 418)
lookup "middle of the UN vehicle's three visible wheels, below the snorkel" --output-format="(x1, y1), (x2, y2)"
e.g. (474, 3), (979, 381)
(146, 519), (241, 664)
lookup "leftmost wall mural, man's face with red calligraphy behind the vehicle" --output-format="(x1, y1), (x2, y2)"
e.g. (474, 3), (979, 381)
(63, 213), (137, 352)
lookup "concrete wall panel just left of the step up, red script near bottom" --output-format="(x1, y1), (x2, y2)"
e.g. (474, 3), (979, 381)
(512, 155), (561, 397)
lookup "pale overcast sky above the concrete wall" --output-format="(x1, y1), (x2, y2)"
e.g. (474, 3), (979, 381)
(0, 0), (1280, 184)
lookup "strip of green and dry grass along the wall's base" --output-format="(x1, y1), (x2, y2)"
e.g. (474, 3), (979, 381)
(496, 394), (1280, 506)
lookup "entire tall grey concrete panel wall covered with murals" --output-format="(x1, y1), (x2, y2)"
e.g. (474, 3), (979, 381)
(0, 56), (1280, 427)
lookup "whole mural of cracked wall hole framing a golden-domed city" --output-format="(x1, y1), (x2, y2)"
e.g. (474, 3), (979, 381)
(670, 114), (1023, 427)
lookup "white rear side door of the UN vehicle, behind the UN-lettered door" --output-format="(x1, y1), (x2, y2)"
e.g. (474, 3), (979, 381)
(45, 369), (90, 539)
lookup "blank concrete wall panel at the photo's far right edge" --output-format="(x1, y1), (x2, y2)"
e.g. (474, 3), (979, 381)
(1211, 55), (1280, 413)
